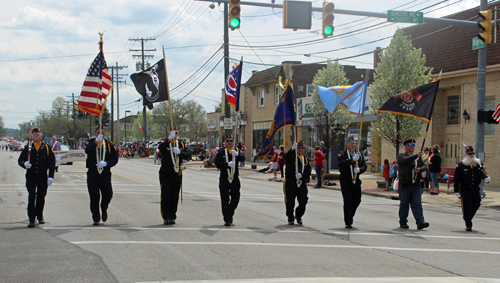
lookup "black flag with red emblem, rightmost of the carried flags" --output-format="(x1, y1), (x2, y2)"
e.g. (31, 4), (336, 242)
(377, 79), (440, 122)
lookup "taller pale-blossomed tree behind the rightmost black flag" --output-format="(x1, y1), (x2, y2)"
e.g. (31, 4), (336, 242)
(370, 29), (433, 159)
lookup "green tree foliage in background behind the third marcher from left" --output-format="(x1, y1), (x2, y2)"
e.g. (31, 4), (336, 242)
(152, 99), (207, 141)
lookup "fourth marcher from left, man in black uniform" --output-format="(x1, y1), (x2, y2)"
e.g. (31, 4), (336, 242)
(214, 134), (245, 226)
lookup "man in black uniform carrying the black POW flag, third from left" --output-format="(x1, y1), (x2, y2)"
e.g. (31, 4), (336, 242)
(158, 127), (191, 225)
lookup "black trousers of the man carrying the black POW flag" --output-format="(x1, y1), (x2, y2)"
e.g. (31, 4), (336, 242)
(160, 173), (182, 220)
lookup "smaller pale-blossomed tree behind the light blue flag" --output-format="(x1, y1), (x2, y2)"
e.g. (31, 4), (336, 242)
(311, 60), (352, 165)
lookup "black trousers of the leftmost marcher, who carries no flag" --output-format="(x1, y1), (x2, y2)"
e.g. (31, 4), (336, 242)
(26, 174), (48, 222)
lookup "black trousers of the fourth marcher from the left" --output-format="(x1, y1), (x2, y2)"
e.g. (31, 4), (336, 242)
(219, 177), (241, 223)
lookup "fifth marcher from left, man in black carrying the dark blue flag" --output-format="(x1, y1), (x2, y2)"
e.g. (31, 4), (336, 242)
(283, 141), (311, 225)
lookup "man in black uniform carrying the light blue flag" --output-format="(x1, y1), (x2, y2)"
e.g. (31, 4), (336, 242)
(337, 136), (366, 229)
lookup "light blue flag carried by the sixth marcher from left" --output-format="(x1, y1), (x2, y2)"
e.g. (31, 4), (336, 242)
(318, 82), (363, 114)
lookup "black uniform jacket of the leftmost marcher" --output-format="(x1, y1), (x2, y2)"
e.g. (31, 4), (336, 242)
(17, 142), (56, 178)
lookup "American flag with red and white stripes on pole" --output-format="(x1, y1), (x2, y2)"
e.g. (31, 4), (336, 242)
(76, 51), (112, 116)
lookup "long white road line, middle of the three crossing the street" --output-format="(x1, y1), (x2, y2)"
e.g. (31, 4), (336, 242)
(70, 241), (500, 255)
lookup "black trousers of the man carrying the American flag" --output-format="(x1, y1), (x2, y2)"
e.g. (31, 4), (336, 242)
(87, 171), (113, 222)
